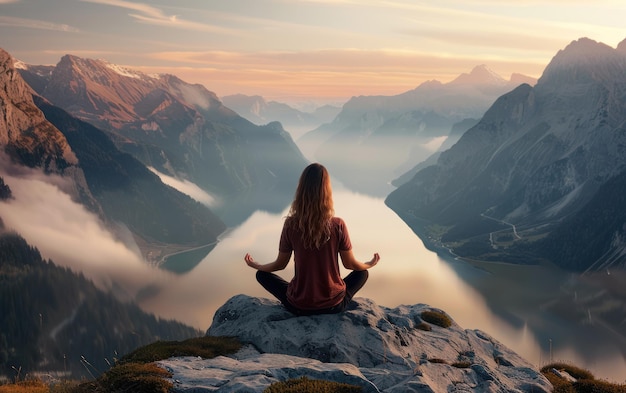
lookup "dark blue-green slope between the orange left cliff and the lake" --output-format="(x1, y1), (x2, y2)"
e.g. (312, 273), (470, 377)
(35, 97), (226, 263)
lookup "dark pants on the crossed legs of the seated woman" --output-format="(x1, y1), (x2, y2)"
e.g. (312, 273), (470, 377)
(256, 270), (369, 315)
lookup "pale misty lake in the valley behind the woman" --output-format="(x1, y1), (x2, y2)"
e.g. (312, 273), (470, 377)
(141, 182), (626, 382)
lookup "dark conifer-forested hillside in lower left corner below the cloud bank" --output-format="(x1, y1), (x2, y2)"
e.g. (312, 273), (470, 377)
(0, 233), (201, 378)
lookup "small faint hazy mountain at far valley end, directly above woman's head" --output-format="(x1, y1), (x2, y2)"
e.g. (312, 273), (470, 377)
(222, 94), (341, 139)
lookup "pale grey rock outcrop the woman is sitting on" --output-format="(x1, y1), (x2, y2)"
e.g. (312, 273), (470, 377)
(160, 295), (552, 392)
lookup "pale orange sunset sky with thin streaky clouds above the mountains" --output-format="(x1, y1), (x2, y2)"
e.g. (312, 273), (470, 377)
(0, 0), (626, 103)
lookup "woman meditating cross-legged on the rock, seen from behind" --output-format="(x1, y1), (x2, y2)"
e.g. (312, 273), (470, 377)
(244, 164), (380, 315)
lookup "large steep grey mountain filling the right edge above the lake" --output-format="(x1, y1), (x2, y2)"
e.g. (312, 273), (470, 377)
(387, 38), (626, 270)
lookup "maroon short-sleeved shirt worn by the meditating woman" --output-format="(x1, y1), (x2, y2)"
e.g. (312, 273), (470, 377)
(278, 217), (352, 310)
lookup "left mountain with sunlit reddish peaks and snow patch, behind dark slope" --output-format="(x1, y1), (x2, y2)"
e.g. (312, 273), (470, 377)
(20, 55), (306, 205)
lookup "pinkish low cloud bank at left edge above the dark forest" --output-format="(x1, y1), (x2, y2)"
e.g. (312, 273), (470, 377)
(0, 159), (169, 299)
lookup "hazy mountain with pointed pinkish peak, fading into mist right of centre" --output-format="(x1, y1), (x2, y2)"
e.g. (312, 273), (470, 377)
(298, 65), (532, 195)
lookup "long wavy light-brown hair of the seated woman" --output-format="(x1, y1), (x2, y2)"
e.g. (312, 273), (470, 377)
(288, 163), (335, 248)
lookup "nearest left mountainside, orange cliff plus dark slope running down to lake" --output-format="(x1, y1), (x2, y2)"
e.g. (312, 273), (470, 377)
(0, 51), (225, 262)
